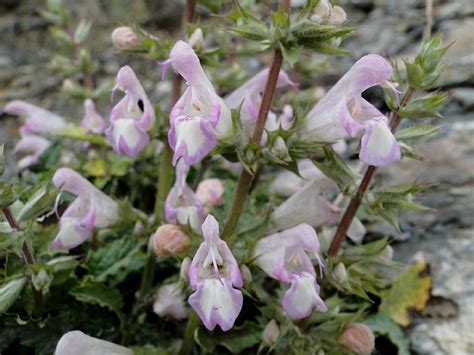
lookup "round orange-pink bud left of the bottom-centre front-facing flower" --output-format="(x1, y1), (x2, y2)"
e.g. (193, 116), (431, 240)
(154, 224), (191, 258)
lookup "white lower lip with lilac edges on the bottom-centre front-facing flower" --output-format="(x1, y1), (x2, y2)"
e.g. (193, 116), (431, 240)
(188, 279), (243, 331)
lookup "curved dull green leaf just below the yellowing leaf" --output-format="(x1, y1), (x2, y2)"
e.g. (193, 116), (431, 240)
(363, 313), (410, 355)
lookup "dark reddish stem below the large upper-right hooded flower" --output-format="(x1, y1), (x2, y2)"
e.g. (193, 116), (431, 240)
(328, 88), (415, 256)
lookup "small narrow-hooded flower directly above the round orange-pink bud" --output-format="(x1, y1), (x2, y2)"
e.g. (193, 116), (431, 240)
(165, 159), (204, 229)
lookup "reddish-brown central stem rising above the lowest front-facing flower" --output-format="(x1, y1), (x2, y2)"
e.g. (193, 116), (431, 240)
(221, 0), (291, 239)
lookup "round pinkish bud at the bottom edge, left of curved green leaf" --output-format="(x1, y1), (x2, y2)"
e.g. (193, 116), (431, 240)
(338, 323), (375, 355)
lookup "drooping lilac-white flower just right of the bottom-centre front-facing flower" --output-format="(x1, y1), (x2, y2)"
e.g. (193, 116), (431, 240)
(253, 223), (327, 319)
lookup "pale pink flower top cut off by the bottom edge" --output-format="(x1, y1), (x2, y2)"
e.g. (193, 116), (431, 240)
(54, 330), (133, 355)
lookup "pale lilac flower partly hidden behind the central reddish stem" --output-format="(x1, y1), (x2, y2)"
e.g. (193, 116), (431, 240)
(225, 68), (294, 138)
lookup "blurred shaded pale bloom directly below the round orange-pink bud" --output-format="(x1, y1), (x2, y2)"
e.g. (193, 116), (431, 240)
(153, 283), (189, 319)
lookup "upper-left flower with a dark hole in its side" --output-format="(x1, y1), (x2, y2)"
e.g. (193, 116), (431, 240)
(105, 65), (155, 157)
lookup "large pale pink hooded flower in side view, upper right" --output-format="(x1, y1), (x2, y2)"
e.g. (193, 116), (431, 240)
(300, 54), (400, 166)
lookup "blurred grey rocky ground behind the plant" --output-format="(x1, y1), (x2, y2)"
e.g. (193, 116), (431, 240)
(0, 0), (474, 355)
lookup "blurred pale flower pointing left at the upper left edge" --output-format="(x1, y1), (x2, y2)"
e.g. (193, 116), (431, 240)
(4, 100), (67, 135)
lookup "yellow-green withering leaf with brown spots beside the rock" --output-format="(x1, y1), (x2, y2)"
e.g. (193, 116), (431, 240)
(380, 262), (431, 326)
